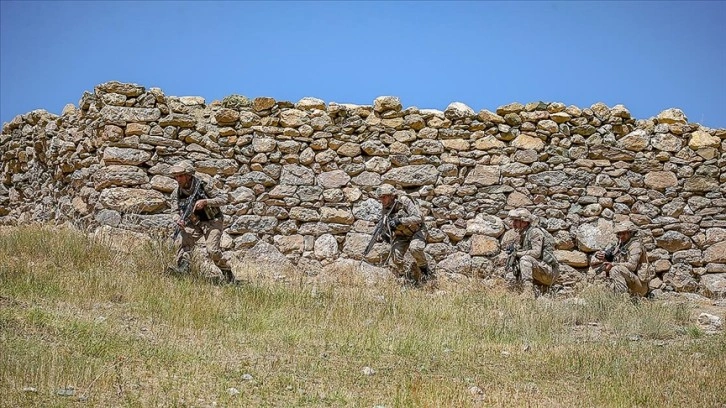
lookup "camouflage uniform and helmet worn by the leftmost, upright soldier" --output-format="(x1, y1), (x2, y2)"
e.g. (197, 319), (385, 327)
(171, 162), (234, 280)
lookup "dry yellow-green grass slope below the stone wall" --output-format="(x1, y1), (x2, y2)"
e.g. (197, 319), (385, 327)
(0, 227), (726, 407)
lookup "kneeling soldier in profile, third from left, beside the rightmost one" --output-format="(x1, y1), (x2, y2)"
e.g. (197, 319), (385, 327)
(509, 208), (560, 297)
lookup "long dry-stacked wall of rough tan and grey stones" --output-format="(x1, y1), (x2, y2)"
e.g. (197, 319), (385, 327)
(0, 82), (726, 296)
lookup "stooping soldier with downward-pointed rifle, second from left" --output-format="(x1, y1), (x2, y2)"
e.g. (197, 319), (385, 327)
(378, 184), (433, 283)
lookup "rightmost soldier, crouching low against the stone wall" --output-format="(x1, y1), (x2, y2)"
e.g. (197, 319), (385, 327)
(595, 221), (653, 296)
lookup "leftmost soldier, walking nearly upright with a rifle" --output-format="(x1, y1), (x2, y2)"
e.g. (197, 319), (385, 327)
(170, 160), (235, 282)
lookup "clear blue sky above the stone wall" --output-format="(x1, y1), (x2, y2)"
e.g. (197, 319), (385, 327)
(0, 0), (726, 128)
